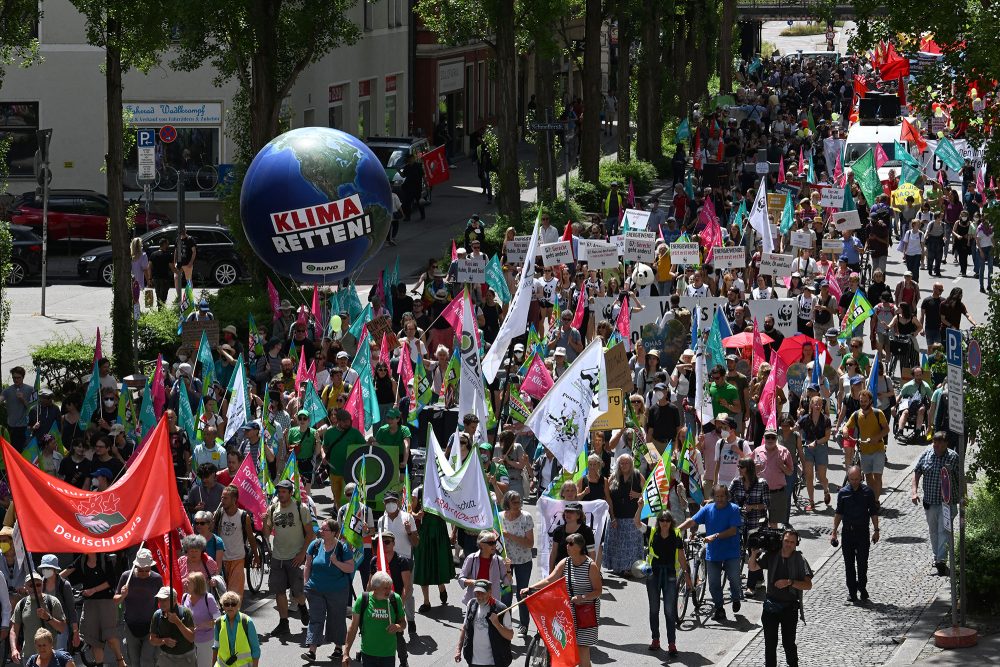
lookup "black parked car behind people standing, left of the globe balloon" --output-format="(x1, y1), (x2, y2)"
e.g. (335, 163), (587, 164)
(76, 224), (246, 287)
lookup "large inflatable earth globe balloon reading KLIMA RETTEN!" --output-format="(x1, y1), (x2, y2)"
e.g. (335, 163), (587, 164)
(240, 127), (392, 284)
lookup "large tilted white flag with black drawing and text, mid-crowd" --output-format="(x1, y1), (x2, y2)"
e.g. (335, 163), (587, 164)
(526, 337), (608, 472)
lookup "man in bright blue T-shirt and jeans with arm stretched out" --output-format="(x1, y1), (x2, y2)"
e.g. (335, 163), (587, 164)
(678, 484), (743, 621)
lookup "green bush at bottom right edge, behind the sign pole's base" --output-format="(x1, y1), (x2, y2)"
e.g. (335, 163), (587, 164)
(965, 484), (1000, 614)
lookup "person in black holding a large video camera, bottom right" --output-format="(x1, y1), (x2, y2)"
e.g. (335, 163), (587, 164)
(750, 528), (813, 667)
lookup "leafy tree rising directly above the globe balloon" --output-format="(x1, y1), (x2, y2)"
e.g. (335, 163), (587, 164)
(172, 0), (361, 165)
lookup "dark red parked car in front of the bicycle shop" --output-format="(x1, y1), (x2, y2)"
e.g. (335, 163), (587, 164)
(8, 190), (170, 241)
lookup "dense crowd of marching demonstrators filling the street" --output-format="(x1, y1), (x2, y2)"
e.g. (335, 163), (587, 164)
(0, 45), (995, 667)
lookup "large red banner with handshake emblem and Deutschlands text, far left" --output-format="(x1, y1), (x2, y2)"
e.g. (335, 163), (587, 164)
(0, 419), (190, 553)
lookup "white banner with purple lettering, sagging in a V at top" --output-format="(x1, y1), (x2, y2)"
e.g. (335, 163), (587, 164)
(424, 429), (493, 530)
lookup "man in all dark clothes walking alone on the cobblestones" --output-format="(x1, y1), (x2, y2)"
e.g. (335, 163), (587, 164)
(830, 466), (879, 604)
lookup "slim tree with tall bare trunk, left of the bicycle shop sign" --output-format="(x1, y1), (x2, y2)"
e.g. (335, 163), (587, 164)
(71, 0), (171, 377)
